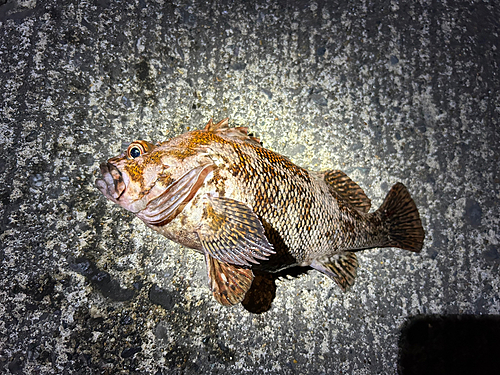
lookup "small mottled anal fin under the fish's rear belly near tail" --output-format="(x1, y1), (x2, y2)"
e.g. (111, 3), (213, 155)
(310, 252), (358, 292)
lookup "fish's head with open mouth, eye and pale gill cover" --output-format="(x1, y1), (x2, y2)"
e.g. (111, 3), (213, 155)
(95, 138), (215, 225)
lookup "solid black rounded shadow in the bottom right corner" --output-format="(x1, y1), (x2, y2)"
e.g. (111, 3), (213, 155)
(398, 315), (500, 375)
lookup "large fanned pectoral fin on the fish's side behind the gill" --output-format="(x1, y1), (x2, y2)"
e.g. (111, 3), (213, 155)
(198, 198), (274, 266)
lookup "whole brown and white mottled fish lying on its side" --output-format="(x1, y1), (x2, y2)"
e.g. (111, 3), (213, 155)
(95, 118), (425, 306)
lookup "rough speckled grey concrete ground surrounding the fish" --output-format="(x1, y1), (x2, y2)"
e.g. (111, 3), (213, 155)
(0, 0), (500, 374)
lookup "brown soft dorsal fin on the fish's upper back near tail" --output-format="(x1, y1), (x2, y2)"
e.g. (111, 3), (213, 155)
(324, 171), (372, 213)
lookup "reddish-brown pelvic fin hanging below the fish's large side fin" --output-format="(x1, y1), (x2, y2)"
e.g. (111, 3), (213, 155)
(205, 253), (253, 306)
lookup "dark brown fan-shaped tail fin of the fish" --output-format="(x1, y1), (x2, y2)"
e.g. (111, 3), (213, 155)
(376, 182), (425, 253)
